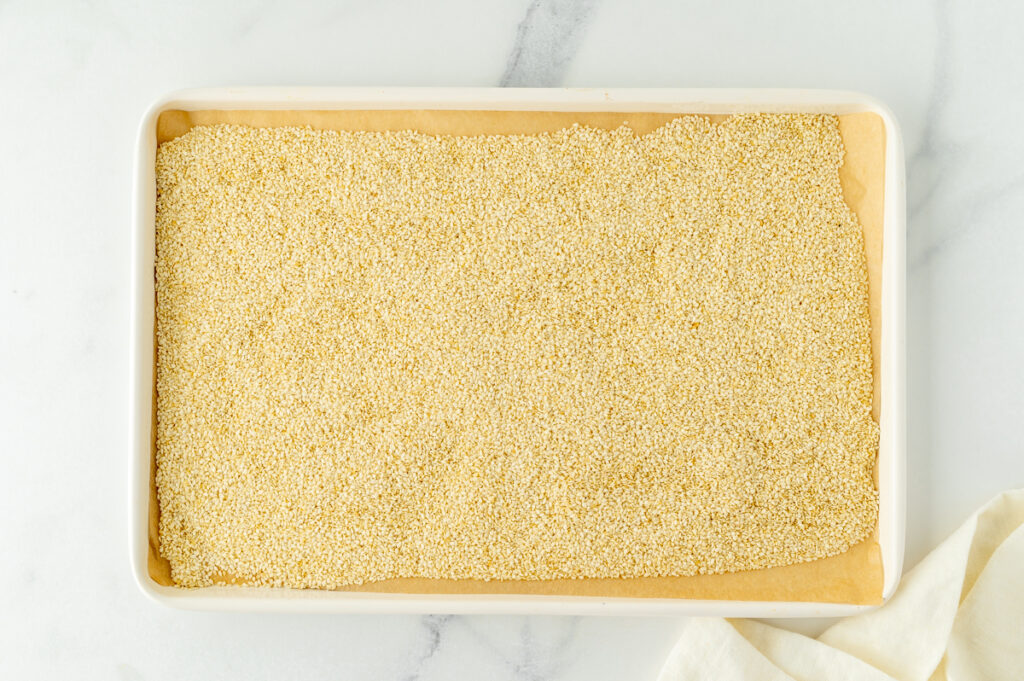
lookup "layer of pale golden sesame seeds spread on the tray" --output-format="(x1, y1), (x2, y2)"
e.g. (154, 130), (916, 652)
(157, 115), (878, 588)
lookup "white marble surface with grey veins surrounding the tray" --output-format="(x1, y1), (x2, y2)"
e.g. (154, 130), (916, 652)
(0, 0), (1024, 680)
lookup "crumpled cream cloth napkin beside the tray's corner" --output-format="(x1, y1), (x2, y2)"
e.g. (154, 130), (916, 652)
(658, 490), (1024, 681)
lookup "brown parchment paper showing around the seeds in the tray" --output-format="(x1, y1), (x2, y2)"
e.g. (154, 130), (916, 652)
(148, 110), (885, 604)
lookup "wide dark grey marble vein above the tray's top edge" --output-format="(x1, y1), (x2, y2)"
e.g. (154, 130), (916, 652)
(501, 0), (597, 87)
